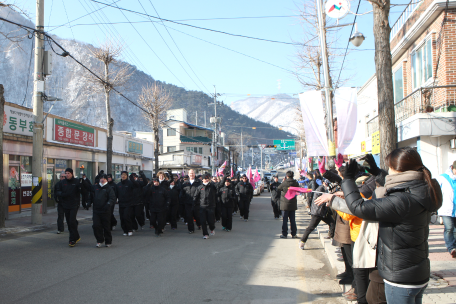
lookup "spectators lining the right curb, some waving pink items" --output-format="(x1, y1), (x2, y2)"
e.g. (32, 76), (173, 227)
(271, 148), (442, 304)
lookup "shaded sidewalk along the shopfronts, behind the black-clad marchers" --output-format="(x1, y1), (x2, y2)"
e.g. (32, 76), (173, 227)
(0, 207), (92, 237)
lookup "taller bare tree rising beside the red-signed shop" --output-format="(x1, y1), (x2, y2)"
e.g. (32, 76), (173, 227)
(84, 39), (132, 173)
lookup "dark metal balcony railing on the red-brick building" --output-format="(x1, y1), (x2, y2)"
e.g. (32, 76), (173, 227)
(367, 85), (456, 136)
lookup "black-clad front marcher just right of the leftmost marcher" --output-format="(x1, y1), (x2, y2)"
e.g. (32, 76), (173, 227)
(88, 174), (117, 247)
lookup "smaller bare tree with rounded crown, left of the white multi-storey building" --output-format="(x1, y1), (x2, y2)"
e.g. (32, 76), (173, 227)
(139, 83), (171, 174)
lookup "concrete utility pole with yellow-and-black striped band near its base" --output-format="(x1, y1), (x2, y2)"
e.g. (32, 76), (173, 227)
(32, 0), (44, 224)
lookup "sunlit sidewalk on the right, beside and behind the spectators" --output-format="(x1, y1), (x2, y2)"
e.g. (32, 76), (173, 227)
(317, 222), (456, 304)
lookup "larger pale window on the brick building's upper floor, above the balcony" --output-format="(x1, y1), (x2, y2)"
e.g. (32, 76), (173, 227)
(412, 39), (432, 89)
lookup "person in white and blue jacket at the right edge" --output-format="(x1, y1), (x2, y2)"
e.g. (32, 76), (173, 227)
(436, 161), (456, 258)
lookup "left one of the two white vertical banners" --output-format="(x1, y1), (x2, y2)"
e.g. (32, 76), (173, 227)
(299, 91), (329, 156)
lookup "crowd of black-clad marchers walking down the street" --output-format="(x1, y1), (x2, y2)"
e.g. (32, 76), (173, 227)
(54, 168), (253, 247)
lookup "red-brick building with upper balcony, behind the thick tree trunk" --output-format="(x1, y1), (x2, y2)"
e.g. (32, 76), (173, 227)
(358, 0), (456, 175)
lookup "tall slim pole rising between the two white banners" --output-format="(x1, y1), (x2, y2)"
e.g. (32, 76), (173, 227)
(317, 0), (336, 156)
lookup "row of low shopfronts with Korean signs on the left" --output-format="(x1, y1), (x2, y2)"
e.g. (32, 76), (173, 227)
(3, 103), (153, 214)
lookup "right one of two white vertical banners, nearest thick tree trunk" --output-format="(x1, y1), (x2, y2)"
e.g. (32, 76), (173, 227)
(334, 88), (361, 155)
